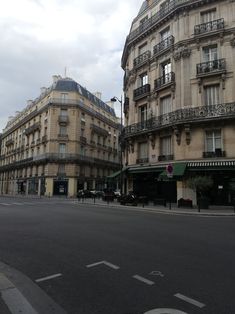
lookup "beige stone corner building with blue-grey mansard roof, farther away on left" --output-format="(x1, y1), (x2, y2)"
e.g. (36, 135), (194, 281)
(0, 76), (120, 196)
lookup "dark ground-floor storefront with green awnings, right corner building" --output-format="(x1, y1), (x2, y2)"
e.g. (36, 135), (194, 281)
(126, 160), (235, 206)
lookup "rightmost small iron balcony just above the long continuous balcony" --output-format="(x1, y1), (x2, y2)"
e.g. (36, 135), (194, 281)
(197, 59), (226, 77)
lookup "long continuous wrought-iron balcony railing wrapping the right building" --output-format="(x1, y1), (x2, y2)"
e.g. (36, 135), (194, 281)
(123, 102), (235, 138)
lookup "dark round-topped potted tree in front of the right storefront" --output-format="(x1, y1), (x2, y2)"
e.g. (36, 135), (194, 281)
(188, 176), (213, 210)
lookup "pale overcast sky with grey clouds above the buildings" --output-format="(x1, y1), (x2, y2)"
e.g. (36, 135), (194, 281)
(0, 0), (143, 132)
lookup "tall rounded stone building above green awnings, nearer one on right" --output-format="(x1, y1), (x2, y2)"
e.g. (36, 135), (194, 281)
(122, 0), (235, 204)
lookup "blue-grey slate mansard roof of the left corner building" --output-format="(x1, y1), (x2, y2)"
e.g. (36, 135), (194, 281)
(53, 78), (116, 117)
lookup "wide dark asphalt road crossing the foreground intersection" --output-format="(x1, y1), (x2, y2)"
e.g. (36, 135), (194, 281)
(0, 197), (235, 314)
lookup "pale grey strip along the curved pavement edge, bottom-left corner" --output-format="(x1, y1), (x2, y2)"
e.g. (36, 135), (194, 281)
(0, 274), (38, 314)
